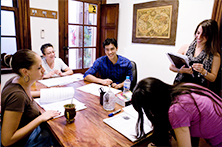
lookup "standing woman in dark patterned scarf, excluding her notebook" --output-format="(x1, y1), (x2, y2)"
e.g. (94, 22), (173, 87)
(170, 19), (221, 87)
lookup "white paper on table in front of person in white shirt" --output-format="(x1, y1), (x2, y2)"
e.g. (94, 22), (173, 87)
(38, 73), (83, 87)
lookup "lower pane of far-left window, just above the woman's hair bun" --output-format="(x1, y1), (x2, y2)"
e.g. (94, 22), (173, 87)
(1, 37), (17, 54)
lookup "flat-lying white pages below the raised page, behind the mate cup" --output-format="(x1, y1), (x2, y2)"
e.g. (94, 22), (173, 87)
(35, 98), (87, 117)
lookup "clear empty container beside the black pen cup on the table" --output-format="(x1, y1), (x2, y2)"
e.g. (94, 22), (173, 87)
(103, 86), (116, 111)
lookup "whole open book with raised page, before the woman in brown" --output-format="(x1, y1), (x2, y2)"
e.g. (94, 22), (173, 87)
(35, 87), (86, 116)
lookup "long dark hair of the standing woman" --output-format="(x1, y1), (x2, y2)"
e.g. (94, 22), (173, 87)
(194, 19), (220, 55)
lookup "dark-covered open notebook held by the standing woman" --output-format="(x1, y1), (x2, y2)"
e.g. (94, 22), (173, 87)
(167, 52), (189, 68)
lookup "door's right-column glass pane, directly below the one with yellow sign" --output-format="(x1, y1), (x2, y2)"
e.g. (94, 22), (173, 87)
(84, 26), (97, 47)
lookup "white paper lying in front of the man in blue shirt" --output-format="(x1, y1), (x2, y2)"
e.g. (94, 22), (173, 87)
(77, 83), (121, 96)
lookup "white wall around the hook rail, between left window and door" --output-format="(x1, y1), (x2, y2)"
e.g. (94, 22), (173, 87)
(30, 0), (59, 57)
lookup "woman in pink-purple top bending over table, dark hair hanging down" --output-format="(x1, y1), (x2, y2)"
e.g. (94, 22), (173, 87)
(132, 78), (222, 147)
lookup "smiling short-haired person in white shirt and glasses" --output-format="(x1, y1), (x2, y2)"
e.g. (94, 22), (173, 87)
(41, 43), (73, 78)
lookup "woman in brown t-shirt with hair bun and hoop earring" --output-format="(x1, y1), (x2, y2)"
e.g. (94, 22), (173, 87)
(1, 49), (59, 147)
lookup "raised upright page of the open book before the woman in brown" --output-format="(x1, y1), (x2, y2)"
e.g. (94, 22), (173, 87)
(40, 87), (74, 104)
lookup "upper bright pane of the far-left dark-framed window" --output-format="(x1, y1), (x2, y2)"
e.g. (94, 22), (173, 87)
(1, 10), (15, 36)
